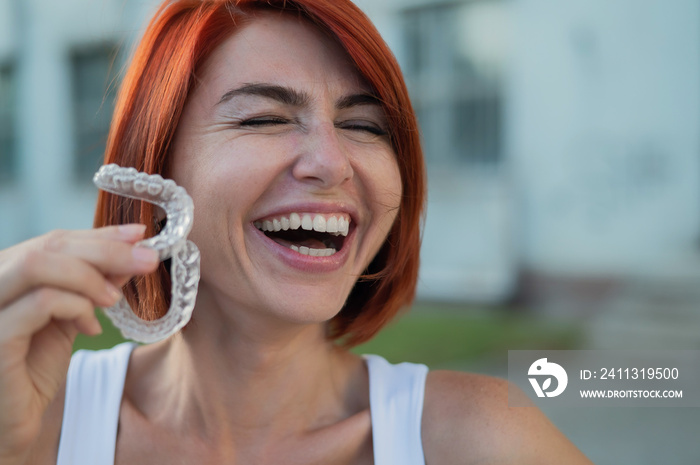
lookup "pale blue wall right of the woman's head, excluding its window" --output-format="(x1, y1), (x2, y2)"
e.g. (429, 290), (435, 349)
(358, 0), (700, 299)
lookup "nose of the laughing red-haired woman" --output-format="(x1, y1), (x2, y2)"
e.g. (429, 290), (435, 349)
(292, 123), (353, 189)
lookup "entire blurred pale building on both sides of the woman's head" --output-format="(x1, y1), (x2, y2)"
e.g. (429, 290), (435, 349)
(0, 0), (700, 301)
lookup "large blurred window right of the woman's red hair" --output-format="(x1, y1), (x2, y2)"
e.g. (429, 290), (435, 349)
(403, 0), (507, 168)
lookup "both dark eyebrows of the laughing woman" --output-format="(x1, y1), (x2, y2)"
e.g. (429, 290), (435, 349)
(217, 83), (381, 110)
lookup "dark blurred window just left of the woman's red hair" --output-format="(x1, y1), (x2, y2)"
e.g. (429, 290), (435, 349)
(71, 45), (116, 181)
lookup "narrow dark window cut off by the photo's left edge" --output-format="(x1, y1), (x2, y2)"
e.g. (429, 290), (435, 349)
(0, 64), (17, 183)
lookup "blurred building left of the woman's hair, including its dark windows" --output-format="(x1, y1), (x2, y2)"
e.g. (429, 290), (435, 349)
(0, 0), (153, 247)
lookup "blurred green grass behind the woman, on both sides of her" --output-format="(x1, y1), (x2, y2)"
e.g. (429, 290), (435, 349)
(73, 303), (580, 369)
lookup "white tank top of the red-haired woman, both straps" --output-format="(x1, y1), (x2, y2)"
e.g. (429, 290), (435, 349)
(57, 343), (428, 465)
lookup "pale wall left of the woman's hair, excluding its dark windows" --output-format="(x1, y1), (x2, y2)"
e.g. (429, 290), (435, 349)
(0, 0), (154, 247)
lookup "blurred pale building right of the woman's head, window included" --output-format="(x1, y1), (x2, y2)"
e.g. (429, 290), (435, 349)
(360, 0), (700, 300)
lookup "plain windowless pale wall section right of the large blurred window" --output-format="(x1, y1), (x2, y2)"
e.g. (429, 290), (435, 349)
(508, 0), (700, 274)
